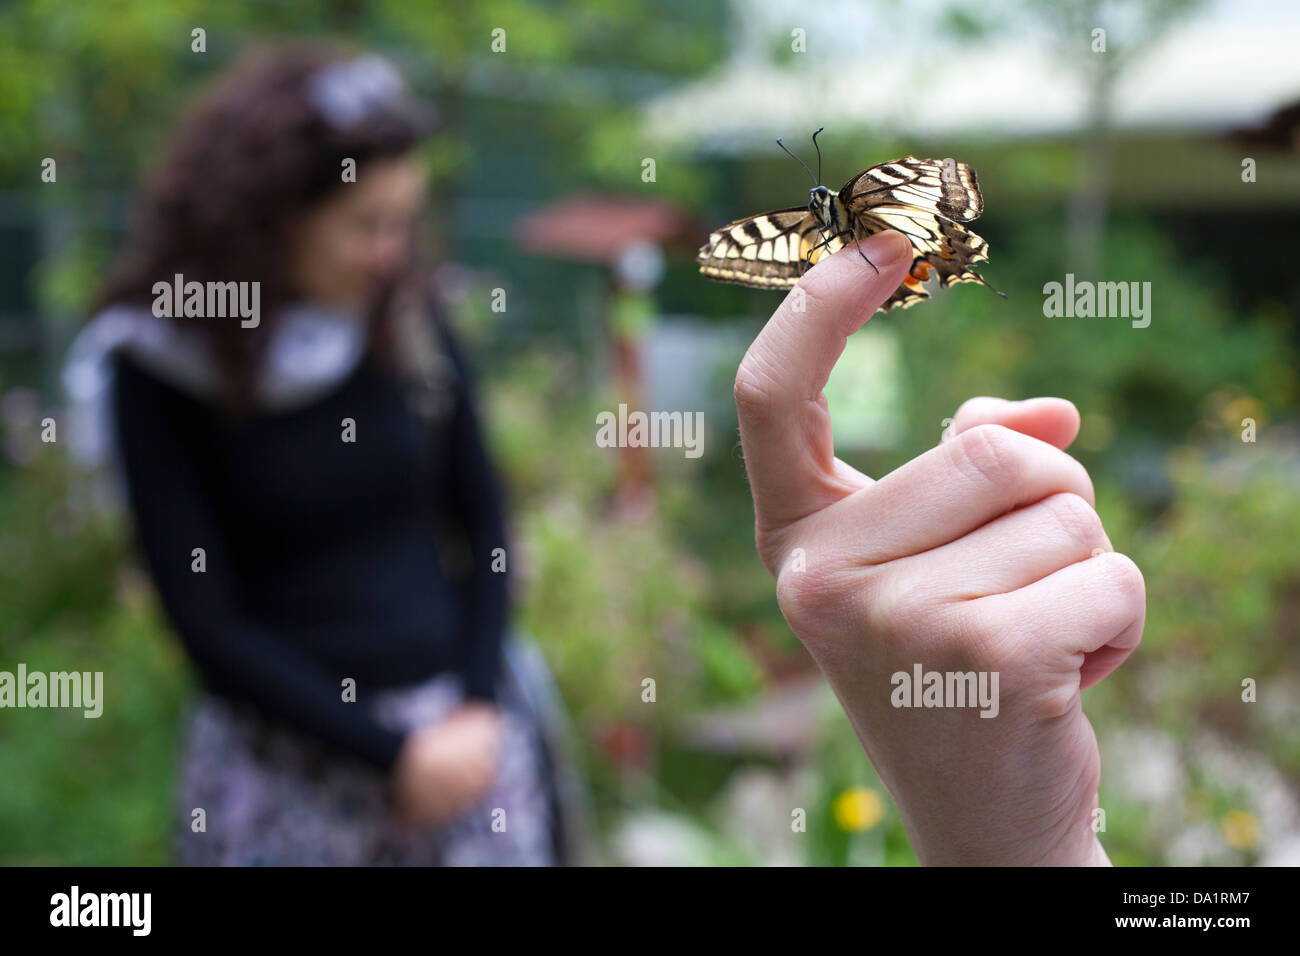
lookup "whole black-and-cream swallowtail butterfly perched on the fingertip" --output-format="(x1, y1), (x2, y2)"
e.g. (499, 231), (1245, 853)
(696, 130), (1006, 312)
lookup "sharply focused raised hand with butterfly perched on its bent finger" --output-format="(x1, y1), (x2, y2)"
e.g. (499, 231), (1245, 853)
(735, 232), (1145, 865)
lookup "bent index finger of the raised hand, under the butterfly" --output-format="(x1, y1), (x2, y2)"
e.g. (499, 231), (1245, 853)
(735, 230), (911, 532)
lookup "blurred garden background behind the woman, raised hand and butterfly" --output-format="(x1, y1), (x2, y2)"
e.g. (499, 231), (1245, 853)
(0, 0), (1300, 865)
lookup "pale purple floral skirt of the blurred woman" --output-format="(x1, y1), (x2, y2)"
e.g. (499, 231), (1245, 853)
(174, 672), (556, 866)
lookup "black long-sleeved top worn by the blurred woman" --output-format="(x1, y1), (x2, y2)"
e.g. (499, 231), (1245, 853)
(114, 314), (507, 771)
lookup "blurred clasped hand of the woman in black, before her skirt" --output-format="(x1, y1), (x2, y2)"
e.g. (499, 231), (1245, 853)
(394, 701), (504, 826)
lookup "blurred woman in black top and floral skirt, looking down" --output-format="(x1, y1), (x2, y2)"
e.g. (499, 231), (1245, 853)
(68, 46), (558, 865)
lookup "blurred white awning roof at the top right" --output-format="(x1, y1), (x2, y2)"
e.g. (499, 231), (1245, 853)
(644, 0), (1300, 153)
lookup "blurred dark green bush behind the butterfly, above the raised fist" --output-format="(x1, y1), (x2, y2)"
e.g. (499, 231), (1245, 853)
(872, 219), (1296, 481)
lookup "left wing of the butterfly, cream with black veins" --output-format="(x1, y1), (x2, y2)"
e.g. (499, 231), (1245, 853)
(696, 207), (853, 289)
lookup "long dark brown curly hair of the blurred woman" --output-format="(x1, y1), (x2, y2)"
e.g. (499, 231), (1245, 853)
(91, 43), (434, 415)
